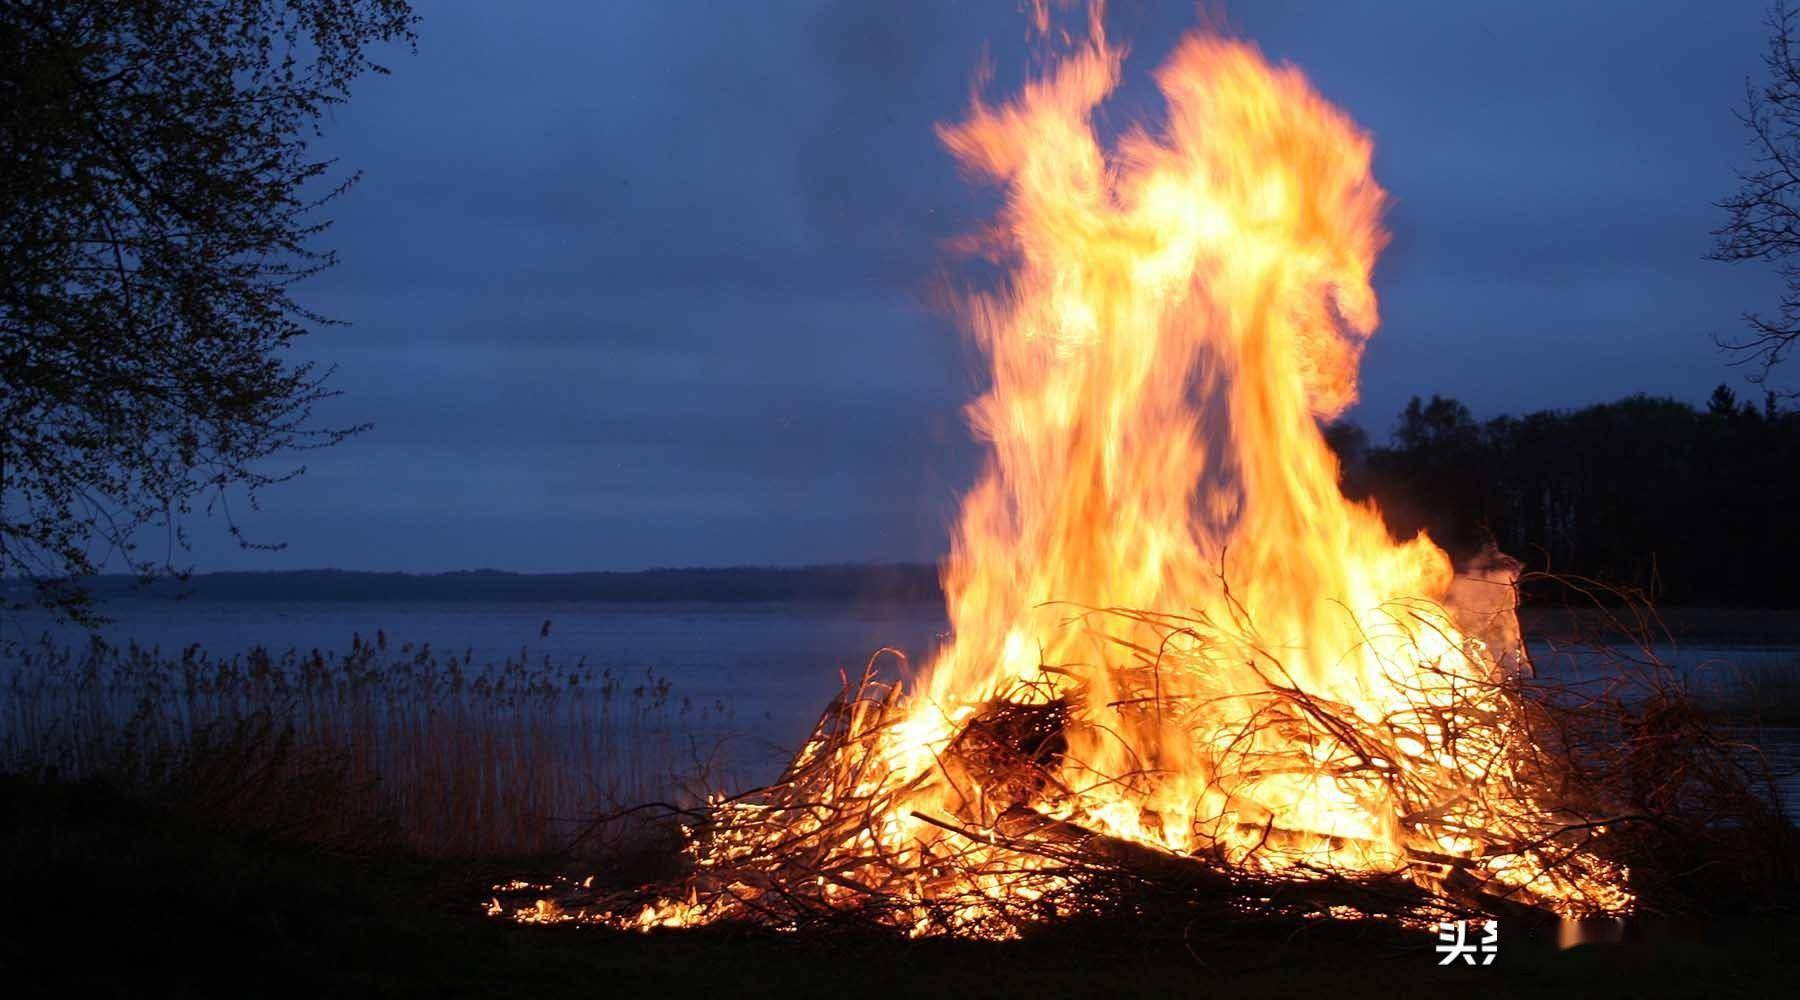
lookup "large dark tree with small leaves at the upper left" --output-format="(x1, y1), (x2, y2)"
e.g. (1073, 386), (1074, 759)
(0, 0), (416, 622)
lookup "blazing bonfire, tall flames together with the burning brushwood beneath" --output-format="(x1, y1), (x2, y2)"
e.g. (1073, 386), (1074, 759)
(493, 9), (1633, 937)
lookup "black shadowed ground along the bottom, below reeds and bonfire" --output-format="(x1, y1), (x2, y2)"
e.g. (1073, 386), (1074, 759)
(0, 777), (1800, 1000)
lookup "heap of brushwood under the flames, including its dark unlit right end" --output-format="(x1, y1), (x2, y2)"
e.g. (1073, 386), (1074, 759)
(490, 589), (1793, 937)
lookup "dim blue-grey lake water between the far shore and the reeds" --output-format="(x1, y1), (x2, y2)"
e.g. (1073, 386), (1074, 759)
(4, 601), (1800, 808)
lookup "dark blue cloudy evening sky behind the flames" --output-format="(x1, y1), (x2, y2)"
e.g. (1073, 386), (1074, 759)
(207, 0), (1777, 570)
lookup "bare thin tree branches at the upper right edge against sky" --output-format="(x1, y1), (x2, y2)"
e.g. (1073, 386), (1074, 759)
(1710, 0), (1800, 396)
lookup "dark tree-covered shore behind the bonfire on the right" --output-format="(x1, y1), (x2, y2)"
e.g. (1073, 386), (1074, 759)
(1327, 385), (1800, 608)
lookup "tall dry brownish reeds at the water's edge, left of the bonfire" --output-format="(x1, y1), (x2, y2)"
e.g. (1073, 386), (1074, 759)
(0, 633), (731, 858)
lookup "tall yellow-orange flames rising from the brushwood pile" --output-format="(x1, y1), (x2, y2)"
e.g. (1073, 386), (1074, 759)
(916, 19), (1472, 866)
